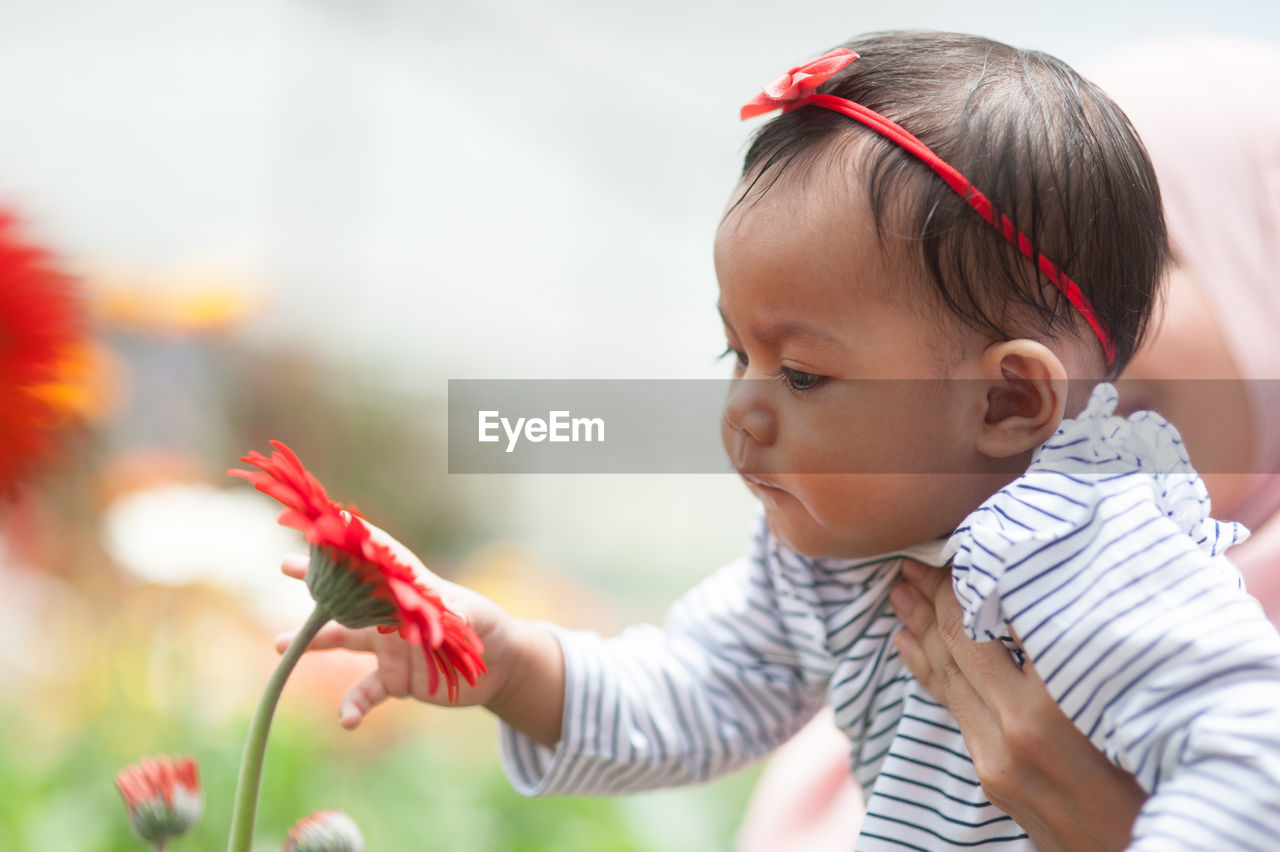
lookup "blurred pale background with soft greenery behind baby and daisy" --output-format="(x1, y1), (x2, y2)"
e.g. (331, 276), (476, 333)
(0, 0), (1280, 852)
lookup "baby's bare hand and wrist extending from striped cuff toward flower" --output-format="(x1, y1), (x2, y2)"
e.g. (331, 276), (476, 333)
(275, 547), (564, 746)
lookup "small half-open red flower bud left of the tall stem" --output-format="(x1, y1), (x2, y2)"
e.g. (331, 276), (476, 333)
(115, 755), (204, 847)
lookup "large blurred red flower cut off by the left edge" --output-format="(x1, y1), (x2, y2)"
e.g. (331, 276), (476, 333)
(0, 211), (84, 495)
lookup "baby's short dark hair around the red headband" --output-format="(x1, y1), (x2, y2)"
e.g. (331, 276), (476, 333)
(742, 32), (1169, 375)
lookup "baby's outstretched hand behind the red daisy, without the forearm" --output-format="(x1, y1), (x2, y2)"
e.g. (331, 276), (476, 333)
(275, 525), (535, 729)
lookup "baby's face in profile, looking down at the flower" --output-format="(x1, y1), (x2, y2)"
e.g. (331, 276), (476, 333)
(716, 175), (1001, 558)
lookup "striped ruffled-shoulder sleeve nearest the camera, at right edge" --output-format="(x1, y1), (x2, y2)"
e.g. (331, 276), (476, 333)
(951, 385), (1280, 849)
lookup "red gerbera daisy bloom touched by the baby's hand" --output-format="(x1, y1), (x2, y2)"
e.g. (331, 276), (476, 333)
(228, 441), (485, 701)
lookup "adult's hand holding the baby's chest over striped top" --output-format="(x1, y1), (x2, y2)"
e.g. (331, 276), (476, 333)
(891, 562), (1147, 852)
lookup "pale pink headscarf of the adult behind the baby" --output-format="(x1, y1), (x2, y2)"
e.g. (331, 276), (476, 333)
(1091, 37), (1280, 623)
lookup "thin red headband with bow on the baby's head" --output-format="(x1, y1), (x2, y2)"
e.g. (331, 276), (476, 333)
(741, 47), (1115, 365)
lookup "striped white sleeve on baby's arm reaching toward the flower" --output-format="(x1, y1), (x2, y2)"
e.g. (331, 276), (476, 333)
(503, 537), (829, 796)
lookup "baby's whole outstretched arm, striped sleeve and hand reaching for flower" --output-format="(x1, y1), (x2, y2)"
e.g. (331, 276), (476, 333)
(276, 519), (829, 794)
